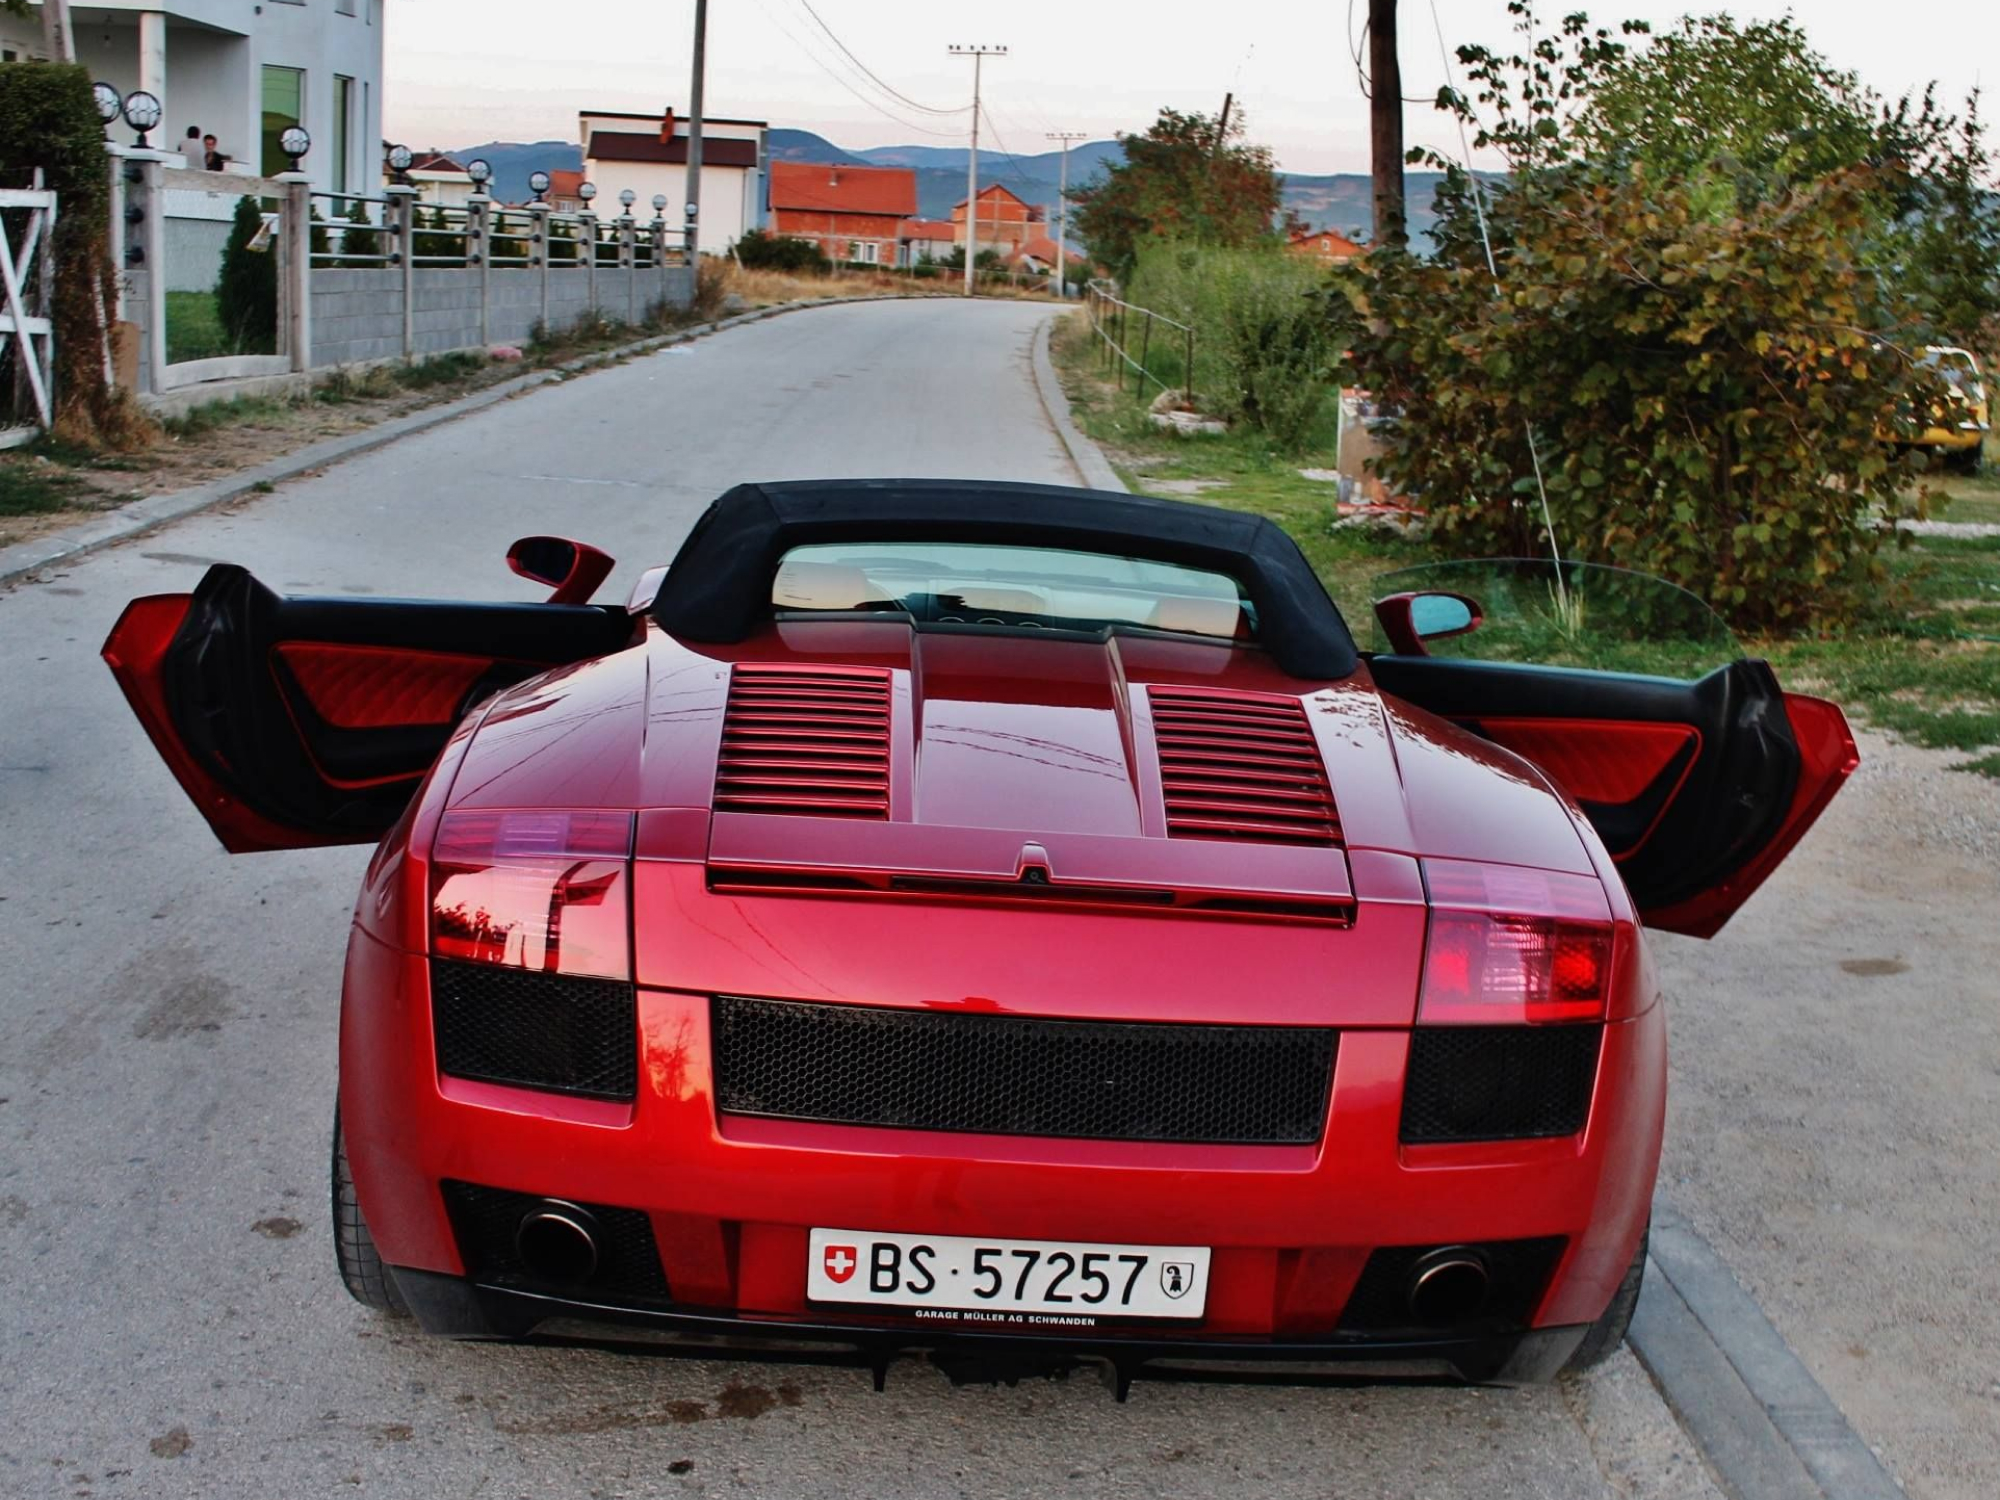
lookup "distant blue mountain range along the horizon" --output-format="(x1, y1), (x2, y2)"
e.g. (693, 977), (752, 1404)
(452, 128), (1440, 238)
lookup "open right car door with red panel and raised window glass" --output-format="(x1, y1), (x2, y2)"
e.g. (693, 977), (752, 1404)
(1370, 562), (1858, 938)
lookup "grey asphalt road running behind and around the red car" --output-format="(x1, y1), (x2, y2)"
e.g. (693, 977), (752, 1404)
(0, 302), (1712, 1500)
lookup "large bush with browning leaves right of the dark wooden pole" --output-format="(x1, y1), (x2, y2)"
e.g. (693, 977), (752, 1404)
(1334, 0), (1932, 628)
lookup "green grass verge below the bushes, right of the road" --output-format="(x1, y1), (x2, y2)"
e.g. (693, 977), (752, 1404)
(1050, 316), (2000, 776)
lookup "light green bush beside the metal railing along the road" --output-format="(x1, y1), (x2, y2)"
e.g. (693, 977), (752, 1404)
(1126, 242), (1338, 450)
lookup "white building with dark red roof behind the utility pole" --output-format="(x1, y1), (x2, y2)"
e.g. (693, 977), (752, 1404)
(578, 110), (770, 254)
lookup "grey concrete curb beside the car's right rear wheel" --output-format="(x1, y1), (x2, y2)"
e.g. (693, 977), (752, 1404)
(1630, 1202), (1902, 1500)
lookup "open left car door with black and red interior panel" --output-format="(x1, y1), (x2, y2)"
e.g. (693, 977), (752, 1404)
(104, 564), (632, 854)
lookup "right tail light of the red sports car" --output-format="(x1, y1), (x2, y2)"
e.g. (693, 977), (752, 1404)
(1416, 860), (1616, 1026)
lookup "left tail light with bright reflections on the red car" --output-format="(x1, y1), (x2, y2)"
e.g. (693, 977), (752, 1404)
(430, 808), (632, 980)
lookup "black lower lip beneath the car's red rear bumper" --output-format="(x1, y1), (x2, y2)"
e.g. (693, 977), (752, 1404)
(394, 1268), (1588, 1396)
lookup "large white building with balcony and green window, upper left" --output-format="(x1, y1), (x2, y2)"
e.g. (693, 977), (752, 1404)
(0, 0), (382, 194)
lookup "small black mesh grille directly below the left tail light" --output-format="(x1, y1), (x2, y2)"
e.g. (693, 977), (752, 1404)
(430, 958), (638, 1098)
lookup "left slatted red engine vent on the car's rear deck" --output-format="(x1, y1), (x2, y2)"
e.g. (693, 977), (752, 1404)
(716, 662), (888, 818)
